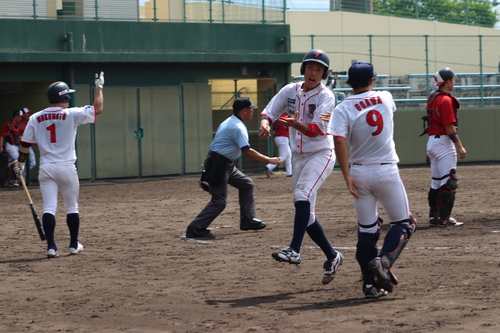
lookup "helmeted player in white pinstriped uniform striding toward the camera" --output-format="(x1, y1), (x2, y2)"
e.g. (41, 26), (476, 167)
(259, 50), (343, 284)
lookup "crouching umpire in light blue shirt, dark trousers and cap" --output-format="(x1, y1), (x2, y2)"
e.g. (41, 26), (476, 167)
(186, 97), (281, 238)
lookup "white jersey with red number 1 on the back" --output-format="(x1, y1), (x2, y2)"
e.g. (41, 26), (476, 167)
(22, 105), (95, 164)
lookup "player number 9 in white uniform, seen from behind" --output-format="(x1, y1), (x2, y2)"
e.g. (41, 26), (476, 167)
(329, 61), (416, 298)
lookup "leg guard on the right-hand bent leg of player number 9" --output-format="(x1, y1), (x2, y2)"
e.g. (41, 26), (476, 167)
(379, 215), (417, 268)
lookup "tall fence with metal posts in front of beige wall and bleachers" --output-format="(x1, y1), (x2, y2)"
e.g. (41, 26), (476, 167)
(291, 35), (500, 107)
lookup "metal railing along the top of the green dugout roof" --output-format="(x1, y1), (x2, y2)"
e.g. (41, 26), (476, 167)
(0, 0), (286, 24)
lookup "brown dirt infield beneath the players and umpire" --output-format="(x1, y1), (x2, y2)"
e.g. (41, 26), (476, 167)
(0, 165), (500, 333)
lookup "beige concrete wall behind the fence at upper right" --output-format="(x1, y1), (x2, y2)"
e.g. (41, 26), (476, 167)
(287, 11), (500, 76)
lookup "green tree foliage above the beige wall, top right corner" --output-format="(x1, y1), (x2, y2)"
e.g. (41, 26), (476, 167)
(373, 0), (500, 28)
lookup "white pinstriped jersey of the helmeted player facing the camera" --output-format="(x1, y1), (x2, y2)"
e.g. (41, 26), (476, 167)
(262, 82), (335, 153)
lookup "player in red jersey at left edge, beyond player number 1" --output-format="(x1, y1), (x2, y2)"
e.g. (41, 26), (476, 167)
(0, 110), (25, 187)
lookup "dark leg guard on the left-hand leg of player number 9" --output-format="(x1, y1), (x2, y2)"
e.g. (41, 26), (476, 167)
(356, 218), (381, 284)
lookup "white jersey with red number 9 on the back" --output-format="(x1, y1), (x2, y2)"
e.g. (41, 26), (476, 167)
(328, 91), (399, 164)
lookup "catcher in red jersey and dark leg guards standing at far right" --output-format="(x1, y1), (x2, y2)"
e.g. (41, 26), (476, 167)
(427, 67), (467, 227)
